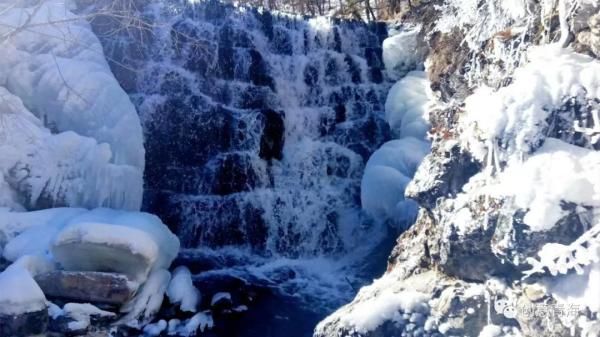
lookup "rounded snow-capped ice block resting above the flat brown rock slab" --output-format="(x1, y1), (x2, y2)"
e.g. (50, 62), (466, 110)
(51, 209), (179, 281)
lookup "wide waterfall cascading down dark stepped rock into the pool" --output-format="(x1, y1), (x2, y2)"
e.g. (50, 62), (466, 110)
(93, 1), (391, 334)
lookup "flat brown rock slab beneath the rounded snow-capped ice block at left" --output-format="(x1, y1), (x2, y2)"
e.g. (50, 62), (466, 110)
(35, 271), (133, 305)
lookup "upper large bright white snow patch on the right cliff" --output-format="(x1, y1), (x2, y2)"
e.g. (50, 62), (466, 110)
(461, 45), (600, 161)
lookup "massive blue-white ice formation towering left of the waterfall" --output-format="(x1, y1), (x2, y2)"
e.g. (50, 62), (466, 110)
(0, 0), (144, 210)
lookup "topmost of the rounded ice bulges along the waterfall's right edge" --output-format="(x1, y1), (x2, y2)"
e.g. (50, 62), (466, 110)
(382, 25), (424, 80)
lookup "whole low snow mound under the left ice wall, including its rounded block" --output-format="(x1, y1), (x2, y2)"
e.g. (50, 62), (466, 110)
(0, 208), (179, 281)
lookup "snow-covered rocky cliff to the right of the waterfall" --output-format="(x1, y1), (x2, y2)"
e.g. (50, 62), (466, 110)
(315, 0), (600, 337)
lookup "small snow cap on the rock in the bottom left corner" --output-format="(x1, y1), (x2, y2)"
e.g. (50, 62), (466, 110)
(0, 265), (46, 315)
